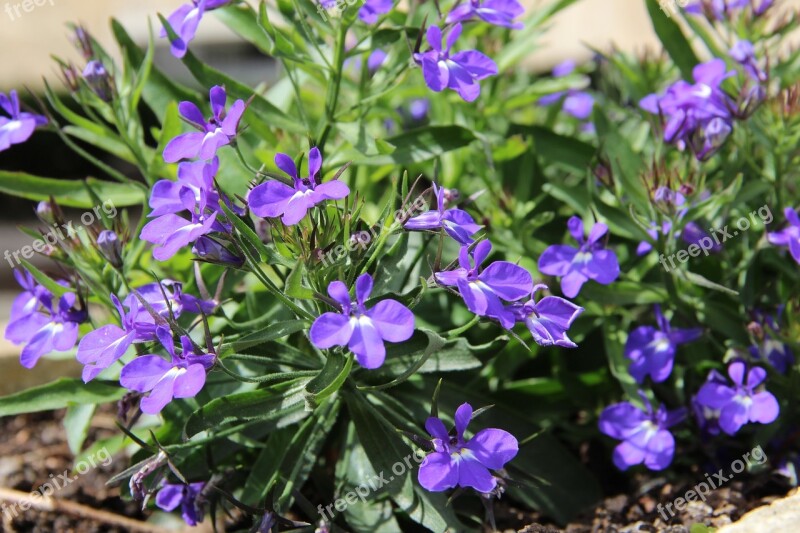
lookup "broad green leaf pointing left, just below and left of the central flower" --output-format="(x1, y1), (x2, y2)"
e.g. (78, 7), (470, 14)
(184, 378), (309, 437)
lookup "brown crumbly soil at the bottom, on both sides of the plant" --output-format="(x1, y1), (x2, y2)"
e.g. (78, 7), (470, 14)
(0, 408), (785, 533)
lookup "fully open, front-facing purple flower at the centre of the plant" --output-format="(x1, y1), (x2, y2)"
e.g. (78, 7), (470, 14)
(308, 274), (414, 369)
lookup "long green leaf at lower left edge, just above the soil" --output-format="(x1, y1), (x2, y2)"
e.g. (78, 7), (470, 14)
(0, 378), (127, 416)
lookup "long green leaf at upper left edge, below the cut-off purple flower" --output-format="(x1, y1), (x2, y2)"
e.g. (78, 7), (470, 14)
(0, 170), (144, 209)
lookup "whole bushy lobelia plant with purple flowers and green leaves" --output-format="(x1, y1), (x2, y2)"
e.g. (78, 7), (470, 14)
(0, 0), (800, 532)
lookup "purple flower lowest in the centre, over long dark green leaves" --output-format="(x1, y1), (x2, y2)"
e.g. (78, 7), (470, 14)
(418, 403), (519, 493)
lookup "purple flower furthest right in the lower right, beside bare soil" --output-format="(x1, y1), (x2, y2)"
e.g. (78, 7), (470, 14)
(697, 361), (780, 435)
